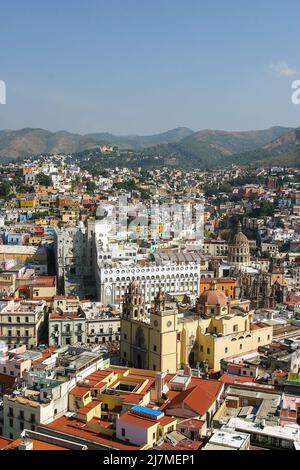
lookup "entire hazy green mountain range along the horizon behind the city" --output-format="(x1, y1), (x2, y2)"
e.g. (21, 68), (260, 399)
(0, 126), (300, 168)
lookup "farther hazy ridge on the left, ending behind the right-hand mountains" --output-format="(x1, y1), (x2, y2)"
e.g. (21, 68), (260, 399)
(0, 127), (193, 161)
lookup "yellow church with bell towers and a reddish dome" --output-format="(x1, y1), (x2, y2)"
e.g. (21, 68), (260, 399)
(120, 281), (273, 373)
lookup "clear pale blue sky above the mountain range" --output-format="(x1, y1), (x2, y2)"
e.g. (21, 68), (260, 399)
(0, 0), (300, 135)
